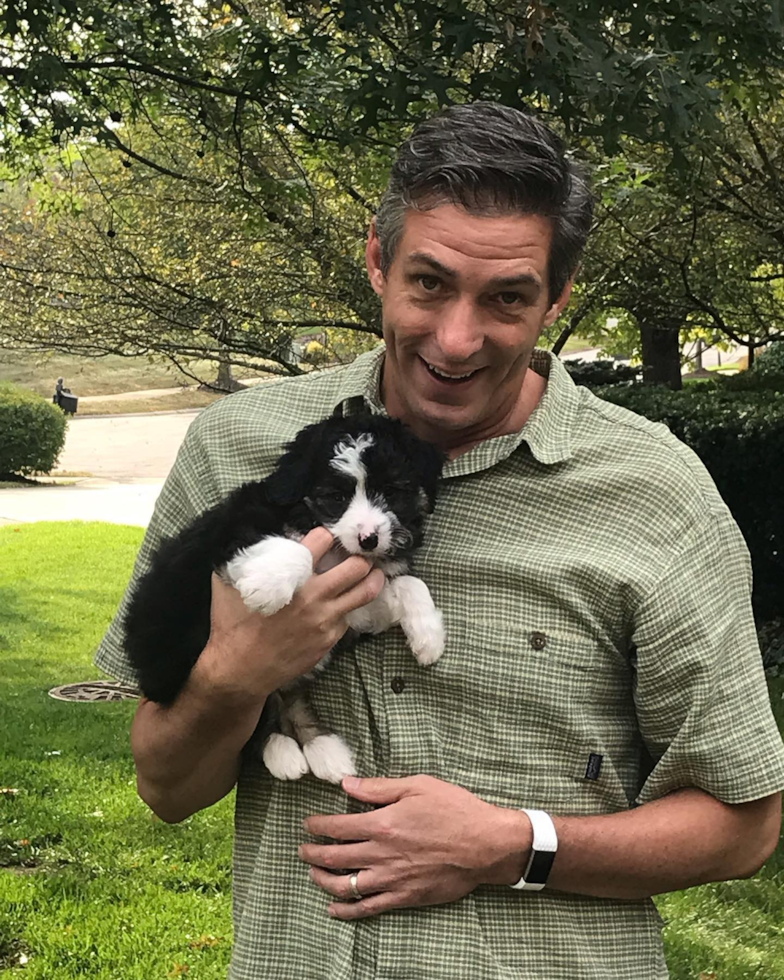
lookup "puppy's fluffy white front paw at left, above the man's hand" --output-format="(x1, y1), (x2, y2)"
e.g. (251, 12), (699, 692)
(226, 537), (313, 616)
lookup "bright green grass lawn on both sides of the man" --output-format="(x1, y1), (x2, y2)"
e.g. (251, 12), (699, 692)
(0, 523), (784, 980)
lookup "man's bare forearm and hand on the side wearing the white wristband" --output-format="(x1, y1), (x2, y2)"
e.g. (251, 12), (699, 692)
(300, 776), (781, 919)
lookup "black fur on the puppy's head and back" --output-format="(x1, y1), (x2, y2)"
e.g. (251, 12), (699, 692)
(124, 414), (443, 704)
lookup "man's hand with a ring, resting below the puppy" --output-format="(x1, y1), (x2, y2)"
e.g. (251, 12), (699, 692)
(299, 776), (532, 919)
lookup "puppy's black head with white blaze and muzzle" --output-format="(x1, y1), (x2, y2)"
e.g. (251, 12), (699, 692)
(267, 414), (444, 559)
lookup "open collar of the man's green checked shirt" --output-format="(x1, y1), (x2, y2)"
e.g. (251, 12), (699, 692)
(334, 343), (580, 478)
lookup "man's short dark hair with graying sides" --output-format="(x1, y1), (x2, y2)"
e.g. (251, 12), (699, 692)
(376, 102), (593, 302)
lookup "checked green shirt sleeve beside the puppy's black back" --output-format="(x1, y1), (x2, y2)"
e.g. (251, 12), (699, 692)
(95, 418), (220, 684)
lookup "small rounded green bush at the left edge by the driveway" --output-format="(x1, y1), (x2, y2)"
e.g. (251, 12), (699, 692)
(0, 381), (66, 475)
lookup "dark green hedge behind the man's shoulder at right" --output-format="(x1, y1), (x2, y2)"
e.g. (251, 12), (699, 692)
(597, 379), (784, 623)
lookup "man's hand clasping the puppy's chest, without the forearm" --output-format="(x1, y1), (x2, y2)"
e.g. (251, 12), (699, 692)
(196, 527), (384, 704)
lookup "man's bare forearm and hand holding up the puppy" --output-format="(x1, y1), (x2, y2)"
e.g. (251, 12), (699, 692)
(131, 528), (384, 823)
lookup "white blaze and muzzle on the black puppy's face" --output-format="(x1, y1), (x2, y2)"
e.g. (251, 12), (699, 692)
(330, 432), (392, 557)
